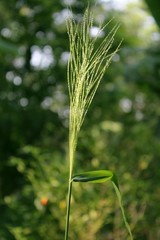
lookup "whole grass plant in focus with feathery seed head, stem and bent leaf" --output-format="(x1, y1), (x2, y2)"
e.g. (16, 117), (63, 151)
(65, 8), (133, 240)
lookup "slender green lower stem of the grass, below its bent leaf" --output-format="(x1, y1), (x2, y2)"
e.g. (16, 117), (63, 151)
(64, 177), (72, 240)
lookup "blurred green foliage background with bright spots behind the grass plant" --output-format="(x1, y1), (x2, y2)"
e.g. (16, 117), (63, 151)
(0, 0), (160, 240)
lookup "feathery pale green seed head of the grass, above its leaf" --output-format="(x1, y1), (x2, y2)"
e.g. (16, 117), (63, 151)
(67, 9), (119, 173)
